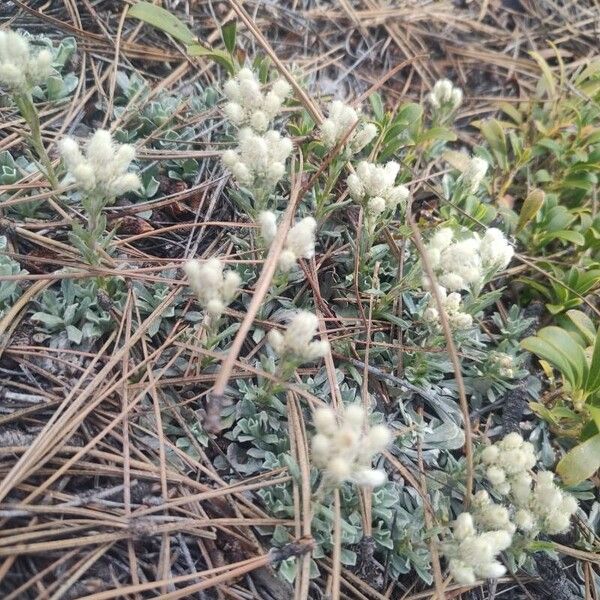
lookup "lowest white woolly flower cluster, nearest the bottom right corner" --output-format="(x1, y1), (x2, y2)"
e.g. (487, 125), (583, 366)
(443, 512), (512, 584)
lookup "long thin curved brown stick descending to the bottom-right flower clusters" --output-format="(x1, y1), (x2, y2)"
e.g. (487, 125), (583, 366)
(407, 214), (473, 508)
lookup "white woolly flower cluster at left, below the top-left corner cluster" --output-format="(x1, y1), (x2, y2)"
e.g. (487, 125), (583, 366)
(59, 129), (141, 199)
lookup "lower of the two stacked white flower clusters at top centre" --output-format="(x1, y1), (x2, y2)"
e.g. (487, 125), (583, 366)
(222, 127), (293, 189)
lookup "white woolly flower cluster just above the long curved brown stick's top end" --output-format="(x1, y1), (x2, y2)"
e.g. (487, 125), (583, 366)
(346, 161), (410, 217)
